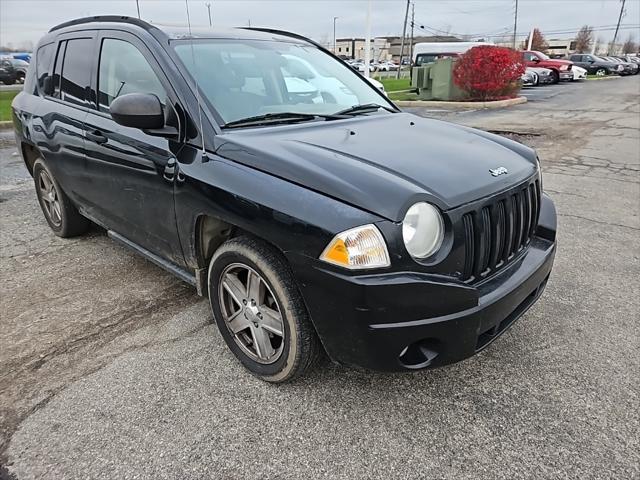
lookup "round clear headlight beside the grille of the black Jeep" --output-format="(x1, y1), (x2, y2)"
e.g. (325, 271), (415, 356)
(402, 202), (444, 258)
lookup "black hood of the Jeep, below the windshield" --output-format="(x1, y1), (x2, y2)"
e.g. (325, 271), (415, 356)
(215, 113), (537, 221)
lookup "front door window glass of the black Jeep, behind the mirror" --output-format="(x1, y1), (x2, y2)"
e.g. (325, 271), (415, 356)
(98, 38), (167, 112)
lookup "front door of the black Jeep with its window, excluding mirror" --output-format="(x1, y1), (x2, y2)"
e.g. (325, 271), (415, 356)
(85, 30), (184, 265)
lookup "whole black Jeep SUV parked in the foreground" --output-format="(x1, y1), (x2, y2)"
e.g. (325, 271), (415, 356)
(13, 17), (556, 382)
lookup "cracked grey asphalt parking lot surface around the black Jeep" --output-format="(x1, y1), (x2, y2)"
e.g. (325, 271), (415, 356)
(0, 76), (640, 480)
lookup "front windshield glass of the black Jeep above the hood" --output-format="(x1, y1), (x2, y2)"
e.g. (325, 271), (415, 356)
(174, 39), (391, 123)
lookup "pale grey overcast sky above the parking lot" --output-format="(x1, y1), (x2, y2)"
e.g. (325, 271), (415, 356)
(0, 0), (640, 48)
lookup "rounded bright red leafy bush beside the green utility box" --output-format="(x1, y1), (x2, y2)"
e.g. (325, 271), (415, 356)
(453, 45), (526, 101)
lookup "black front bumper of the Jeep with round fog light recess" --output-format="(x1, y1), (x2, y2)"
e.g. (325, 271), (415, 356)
(291, 198), (556, 371)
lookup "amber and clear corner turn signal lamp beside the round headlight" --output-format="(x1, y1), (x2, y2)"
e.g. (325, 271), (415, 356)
(320, 225), (391, 270)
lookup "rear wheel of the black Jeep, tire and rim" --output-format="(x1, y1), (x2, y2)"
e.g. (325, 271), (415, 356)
(33, 158), (91, 238)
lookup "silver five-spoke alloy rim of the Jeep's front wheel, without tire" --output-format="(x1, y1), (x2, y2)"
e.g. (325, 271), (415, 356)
(218, 263), (285, 364)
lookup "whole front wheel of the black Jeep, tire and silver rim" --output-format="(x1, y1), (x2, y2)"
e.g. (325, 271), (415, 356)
(207, 237), (322, 383)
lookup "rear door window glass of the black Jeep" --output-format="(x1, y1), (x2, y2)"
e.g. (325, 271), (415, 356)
(60, 38), (93, 106)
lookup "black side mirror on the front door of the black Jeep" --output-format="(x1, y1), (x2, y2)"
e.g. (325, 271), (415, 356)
(109, 93), (164, 130)
